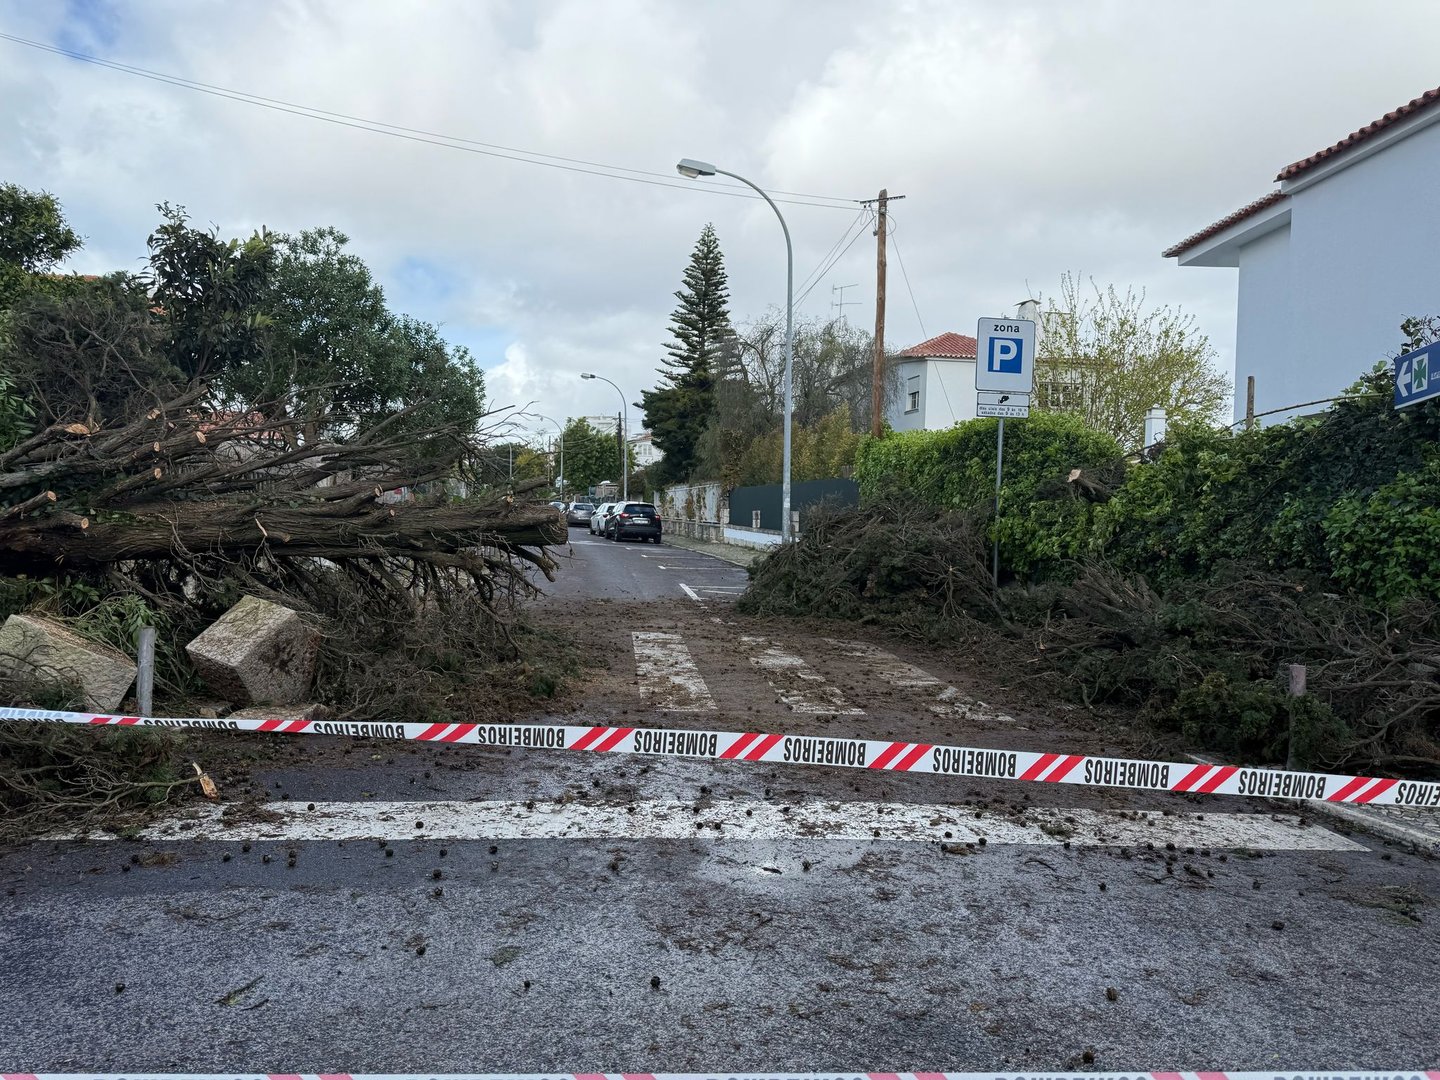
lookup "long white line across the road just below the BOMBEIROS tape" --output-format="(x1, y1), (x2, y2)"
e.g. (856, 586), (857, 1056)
(48, 799), (1365, 861)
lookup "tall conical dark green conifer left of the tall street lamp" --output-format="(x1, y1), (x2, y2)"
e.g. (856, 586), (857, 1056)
(644, 225), (734, 482)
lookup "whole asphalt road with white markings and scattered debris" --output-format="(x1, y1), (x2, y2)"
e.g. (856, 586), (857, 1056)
(0, 530), (1440, 1073)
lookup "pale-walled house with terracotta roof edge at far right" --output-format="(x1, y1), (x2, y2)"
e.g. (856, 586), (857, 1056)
(1164, 89), (1440, 419)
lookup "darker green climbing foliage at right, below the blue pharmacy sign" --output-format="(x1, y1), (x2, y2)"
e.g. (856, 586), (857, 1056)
(1092, 364), (1440, 603)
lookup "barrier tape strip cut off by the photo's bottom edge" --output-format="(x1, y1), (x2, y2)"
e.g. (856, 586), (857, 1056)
(8, 1068), (1440, 1080)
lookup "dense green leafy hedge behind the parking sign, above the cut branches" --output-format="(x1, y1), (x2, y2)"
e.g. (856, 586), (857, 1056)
(857, 364), (1440, 603)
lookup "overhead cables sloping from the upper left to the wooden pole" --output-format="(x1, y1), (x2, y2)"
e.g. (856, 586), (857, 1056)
(0, 32), (857, 210)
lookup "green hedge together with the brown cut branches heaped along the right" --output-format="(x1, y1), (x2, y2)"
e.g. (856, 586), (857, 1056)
(740, 342), (1440, 776)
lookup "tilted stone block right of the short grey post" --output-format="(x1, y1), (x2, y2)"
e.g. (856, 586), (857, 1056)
(184, 596), (320, 706)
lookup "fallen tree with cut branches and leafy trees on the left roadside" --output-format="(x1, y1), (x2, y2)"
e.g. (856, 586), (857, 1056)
(0, 184), (566, 821)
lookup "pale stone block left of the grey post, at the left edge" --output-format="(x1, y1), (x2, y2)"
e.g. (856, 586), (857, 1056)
(0, 615), (135, 713)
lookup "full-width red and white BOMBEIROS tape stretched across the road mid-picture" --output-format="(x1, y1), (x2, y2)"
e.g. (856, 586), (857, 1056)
(0, 708), (1440, 808)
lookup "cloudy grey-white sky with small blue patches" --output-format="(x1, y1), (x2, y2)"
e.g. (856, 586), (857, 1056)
(0, 0), (1440, 440)
